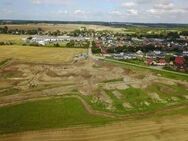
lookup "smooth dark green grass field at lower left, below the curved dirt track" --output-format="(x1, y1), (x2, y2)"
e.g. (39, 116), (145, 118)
(0, 98), (111, 134)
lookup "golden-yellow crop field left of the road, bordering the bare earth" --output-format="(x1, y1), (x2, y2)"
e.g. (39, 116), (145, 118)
(0, 45), (87, 63)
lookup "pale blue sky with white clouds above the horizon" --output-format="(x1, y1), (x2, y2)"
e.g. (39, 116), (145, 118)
(0, 0), (188, 23)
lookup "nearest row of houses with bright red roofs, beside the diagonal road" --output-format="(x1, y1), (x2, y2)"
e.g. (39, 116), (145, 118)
(103, 50), (188, 69)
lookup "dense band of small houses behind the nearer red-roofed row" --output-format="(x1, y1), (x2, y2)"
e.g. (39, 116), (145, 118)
(94, 36), (188, 50)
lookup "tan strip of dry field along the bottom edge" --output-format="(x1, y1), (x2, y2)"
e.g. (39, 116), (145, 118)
(0, 116), (188, 141)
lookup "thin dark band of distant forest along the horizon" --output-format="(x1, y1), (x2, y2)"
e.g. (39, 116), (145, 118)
(0, 20), (188, 28)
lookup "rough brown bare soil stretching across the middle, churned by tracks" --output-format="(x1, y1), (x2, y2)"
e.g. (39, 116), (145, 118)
(0, 57), (188, 107)
